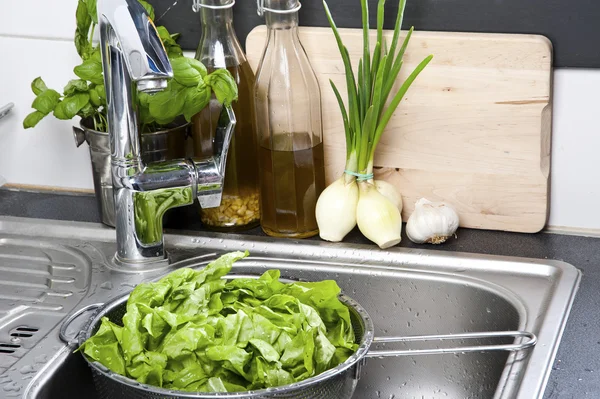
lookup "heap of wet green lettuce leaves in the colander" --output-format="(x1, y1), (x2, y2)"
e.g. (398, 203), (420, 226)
(80, 252), (358, 392)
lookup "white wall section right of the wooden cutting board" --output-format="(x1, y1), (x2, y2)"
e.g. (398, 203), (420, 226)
(549, 69), (600, 230)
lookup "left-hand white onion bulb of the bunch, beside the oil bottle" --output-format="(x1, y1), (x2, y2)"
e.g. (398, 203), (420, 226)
(315, 176), (358, 242)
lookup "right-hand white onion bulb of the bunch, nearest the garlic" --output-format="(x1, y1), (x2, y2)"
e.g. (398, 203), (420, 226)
(356, 182), (402, 249)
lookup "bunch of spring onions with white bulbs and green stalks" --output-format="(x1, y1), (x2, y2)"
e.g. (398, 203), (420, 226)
(316, 0), (433, 248)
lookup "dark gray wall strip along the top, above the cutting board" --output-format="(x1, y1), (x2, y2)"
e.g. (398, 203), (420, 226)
(150, 0), (600, 68)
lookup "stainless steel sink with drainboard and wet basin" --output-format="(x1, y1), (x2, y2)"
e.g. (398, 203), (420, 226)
(0, 218), (580, 399)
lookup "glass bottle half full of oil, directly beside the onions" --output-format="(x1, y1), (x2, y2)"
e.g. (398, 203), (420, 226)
(254, 0), (325, 238)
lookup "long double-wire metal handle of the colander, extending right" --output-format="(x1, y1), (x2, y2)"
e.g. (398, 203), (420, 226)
(366, 331), (537, 357)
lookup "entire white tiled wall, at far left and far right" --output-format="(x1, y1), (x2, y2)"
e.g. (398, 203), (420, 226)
(0, 0), (600, 231)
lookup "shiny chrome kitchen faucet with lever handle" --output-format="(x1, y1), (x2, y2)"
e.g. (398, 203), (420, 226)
(98, 0), (236, 271)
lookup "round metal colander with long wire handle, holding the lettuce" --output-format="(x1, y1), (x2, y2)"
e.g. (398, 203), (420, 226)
(60, 286), (537, 399)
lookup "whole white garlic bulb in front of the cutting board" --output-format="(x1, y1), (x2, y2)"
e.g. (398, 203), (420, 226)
(406, 198), (459, 244)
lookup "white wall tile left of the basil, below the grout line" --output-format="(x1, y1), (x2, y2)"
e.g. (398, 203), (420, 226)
(0, 36), (93, 189)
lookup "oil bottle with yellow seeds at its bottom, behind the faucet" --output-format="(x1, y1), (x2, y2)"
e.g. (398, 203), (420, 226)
(192, 0), (260, 231)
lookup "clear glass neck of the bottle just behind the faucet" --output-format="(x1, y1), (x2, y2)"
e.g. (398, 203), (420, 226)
(196, 7), (246, 70)
